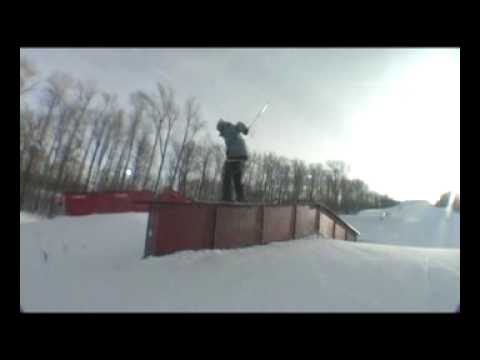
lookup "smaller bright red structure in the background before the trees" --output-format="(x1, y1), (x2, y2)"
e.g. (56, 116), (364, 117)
(64, 191), (153, 216)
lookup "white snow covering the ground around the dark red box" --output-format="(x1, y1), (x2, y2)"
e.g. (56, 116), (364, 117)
(20, 203), (460, 312)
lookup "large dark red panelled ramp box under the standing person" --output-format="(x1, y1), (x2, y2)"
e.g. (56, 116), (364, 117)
(144, 202), (359, 257)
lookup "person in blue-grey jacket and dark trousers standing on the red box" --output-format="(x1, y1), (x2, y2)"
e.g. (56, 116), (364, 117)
(217, 119), (248, 202)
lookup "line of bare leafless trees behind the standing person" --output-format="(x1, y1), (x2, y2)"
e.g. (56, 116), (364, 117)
(20, 58), (394, 216)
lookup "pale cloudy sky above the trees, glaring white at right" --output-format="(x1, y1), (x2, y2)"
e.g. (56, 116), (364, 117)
(21, 48), (460, 202)
